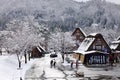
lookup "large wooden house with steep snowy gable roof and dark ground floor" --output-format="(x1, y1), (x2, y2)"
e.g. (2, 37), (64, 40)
(73, 33), (111, 65)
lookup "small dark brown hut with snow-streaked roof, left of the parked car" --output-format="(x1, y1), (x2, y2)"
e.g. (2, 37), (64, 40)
(31, 46), (45, 58)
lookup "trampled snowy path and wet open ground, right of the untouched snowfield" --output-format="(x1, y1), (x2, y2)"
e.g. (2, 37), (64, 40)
(25, 55), (120, 80)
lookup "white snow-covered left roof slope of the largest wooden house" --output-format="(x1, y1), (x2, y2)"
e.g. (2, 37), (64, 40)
(78, 38), (95, 51)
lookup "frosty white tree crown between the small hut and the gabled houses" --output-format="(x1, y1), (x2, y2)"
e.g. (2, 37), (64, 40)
(49, 28), (74, 52)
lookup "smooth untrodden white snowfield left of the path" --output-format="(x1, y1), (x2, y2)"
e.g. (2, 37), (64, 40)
(0, 55), (34, 80)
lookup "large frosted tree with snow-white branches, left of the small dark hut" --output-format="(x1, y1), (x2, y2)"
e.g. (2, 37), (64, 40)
(4, 17), (44, 67)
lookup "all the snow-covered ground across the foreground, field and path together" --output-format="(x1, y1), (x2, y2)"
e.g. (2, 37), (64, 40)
(0, 51), (120, 80)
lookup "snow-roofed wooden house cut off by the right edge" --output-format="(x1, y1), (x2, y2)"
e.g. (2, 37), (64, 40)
(110, 37), (120, 62)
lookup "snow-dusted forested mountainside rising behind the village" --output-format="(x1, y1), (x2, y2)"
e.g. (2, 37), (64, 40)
(0, 0), (120, 30)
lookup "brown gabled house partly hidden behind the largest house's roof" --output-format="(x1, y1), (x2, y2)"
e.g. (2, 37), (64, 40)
(71, 28), (86, 48)
